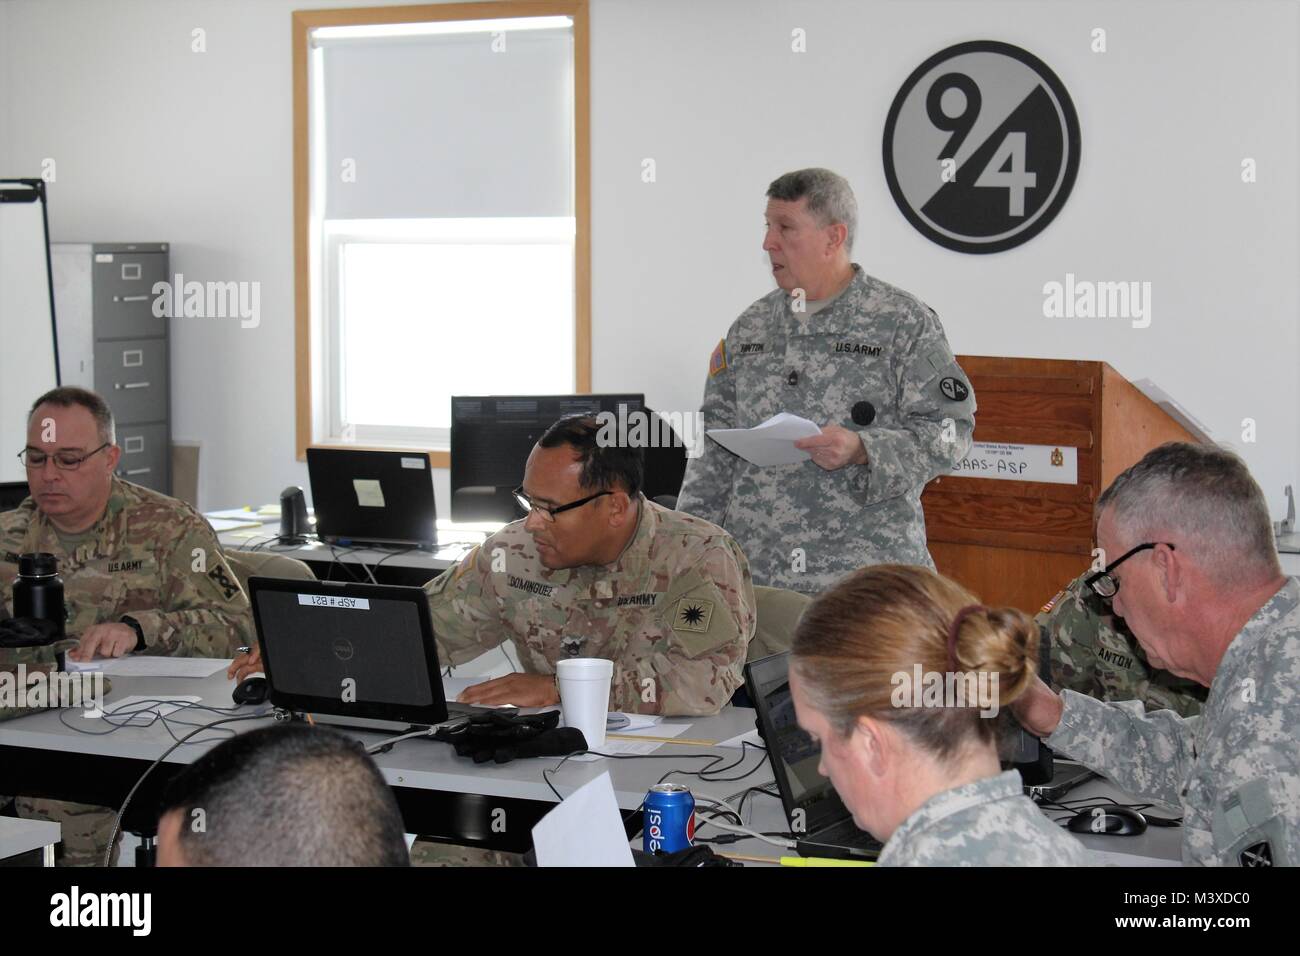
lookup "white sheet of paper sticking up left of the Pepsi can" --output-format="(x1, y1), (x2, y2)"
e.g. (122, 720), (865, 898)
(533, 773), (636, 866)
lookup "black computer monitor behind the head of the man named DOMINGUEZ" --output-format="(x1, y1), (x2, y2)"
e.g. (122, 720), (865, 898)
(451, 393), (686, 522)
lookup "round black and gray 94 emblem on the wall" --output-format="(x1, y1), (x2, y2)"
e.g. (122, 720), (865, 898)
(884, 40), (1079, 252)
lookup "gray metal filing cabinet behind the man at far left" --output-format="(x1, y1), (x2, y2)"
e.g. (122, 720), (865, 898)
(49, 242), (172, 494)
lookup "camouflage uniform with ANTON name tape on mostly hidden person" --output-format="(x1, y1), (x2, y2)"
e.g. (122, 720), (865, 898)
(1035, 571), (1208, 717)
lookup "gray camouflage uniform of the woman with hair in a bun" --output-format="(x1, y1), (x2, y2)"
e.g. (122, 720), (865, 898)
(876, 770), (1096, 866)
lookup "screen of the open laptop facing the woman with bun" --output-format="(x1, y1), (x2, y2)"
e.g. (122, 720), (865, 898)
(745, 653), (849, 830)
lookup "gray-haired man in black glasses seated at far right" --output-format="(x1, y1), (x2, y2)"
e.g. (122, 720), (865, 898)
(1014, 442), (1300, 866)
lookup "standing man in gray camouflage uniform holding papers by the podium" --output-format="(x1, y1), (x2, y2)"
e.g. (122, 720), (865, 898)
(677, 169), (975, 593)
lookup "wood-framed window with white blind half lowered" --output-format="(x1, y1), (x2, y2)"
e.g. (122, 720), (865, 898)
(295, 3), (589, 460)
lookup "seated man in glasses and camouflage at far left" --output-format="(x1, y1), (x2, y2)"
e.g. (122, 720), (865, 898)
(0, 388), (252, 865)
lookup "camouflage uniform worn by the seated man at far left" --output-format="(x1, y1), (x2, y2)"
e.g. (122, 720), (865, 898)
(0, 476), (252, 866)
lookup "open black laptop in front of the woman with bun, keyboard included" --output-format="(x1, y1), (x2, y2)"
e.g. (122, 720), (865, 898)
(745, 652), (881, 860)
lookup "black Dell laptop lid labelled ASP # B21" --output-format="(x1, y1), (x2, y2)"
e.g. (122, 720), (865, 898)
(248, 578), (446, 723)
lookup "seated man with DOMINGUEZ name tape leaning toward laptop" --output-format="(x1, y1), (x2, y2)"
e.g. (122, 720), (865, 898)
(230, 416), (755, 864)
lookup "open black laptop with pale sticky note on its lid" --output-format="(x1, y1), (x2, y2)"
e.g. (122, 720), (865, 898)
(307, 449), (438, 549)
